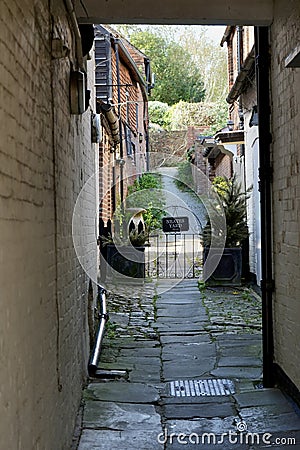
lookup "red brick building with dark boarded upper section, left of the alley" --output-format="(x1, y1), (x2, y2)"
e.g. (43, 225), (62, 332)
(95, 25), (151, 223)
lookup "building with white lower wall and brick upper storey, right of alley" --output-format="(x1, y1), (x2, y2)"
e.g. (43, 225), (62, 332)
(221, 26), (262, 285)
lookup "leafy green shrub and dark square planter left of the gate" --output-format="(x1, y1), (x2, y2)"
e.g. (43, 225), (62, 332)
(100, 172), (165, 278)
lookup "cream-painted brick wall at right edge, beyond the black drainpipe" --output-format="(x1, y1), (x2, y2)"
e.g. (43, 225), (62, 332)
(271, 0), (300, 389)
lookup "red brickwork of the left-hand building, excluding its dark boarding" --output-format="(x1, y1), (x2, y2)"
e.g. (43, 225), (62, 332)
(99, 43), (148, 222)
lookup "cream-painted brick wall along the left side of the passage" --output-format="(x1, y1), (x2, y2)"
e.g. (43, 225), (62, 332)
(0, 0), (96, 450)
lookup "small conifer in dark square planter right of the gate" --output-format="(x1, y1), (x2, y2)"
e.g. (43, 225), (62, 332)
(202, 175), (252, 286)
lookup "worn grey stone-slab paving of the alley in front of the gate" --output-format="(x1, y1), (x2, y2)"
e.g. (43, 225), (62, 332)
(78, 280), (300, 450)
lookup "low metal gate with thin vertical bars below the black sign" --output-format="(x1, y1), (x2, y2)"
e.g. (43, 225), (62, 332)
(145, 233), (202, 278)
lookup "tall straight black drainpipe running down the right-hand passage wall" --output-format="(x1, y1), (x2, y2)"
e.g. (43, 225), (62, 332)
(255, 27), (274, 387)
